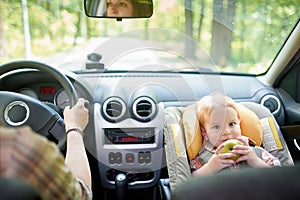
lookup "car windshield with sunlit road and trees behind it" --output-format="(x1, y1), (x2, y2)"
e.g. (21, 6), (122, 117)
(0, 0), (300, 75)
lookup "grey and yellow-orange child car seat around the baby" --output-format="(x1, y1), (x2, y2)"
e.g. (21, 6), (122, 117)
(164, 102), (294, 190)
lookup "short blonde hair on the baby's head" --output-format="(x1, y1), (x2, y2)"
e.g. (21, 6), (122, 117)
(197, 93), (240, 127)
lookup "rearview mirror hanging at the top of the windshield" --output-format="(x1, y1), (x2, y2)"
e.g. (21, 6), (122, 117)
(84, 0), (153, 20)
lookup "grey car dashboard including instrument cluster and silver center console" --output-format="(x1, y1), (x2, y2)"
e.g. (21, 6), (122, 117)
(0, 67), (285, 195)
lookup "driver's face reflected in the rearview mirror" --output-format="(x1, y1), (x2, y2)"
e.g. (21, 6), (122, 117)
(106, 0), (134, 17)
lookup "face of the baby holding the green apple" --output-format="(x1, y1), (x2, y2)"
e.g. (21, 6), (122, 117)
(205, 107), (241, 147)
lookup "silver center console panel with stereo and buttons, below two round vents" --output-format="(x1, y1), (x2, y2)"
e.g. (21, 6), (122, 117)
(94, 103), (165, 189)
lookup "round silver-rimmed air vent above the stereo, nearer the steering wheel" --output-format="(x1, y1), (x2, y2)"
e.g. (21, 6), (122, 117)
(102, 97), (126, 121)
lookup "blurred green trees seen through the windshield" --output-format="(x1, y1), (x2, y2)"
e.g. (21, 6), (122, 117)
(0, 0), (300, 74)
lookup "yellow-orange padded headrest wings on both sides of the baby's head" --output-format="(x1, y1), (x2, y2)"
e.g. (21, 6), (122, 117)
(182, 103), (262, 160)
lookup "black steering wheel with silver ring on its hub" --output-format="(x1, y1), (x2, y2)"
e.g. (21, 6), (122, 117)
(0, 61), (78, 150)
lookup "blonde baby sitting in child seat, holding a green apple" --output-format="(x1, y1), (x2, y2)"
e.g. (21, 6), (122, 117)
(190, 93), (280, 176)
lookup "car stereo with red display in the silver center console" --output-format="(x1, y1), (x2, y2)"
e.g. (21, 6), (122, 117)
(104, 128), (155, 144)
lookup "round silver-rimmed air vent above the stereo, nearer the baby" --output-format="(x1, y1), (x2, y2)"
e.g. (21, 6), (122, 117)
(132, 97), (156, 121)
